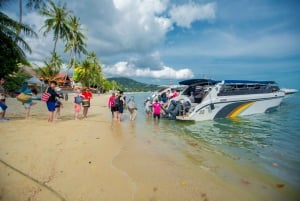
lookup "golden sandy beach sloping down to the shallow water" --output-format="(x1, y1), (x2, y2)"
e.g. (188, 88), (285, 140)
(0, 95), (299, 201)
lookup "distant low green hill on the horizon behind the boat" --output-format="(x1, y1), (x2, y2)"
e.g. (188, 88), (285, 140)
(108, 77), (158, 92)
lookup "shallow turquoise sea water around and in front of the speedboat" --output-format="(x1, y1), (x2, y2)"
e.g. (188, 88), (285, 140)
(128, 70), (300, 188)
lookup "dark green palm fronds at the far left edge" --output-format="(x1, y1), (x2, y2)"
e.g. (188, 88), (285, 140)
(0, 9), (37, 76)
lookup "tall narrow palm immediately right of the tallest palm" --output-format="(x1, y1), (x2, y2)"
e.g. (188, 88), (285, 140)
(65, 15), (87, 68)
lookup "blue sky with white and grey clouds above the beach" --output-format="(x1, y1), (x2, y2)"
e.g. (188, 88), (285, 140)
(4, 0), (300, 84)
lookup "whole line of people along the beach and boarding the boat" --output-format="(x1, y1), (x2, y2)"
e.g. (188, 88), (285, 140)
(0, 78), (172, 122)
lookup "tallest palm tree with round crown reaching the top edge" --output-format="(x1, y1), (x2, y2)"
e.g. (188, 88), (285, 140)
(40, 0), (71, 52)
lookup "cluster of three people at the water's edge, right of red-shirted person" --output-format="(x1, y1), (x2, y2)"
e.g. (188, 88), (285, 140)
(108, 91), (137, 122)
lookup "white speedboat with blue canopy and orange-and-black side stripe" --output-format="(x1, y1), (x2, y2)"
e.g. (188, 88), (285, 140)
(166, 79), (285, 121)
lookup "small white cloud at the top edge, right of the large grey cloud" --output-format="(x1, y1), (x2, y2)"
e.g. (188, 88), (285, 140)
(170, 2), (216, 28)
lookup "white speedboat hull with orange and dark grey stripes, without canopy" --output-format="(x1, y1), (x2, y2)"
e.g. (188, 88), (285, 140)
(176, 92), (284, 121)
